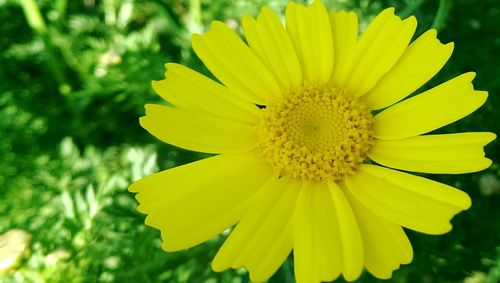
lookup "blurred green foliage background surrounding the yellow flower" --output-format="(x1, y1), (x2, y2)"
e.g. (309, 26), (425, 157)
(0, 0), (500, 283)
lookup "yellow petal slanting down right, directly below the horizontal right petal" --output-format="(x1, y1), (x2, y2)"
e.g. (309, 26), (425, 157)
(346, 164), (471, 234)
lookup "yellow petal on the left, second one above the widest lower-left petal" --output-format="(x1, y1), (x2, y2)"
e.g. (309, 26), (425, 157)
(152, 63), (260, 124)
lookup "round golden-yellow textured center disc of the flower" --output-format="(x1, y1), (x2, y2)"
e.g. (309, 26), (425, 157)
(259, 85), (373, 181)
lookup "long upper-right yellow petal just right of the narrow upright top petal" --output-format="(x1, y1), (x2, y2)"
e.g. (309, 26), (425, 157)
(345, 8), (417, 96)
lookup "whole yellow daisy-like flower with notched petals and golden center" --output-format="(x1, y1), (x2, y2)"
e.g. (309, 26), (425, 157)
(130, 1), (495, 282)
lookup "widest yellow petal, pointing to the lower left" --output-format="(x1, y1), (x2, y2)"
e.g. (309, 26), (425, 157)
(129, 153), (273, 251)
